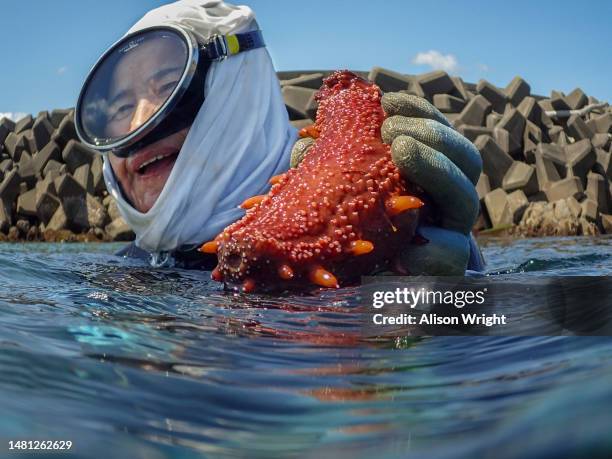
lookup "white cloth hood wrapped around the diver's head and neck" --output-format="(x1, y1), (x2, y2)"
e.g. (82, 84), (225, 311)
(103, 0), (296, 258)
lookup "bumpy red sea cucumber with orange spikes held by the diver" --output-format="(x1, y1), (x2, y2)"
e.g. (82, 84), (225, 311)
(208, 71), (422, 291)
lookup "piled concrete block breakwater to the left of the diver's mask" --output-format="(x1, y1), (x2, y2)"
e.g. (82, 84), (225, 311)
(0, 109), (134, 242)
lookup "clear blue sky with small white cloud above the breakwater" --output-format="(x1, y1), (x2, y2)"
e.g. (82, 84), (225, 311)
(0, 0), (612, 118)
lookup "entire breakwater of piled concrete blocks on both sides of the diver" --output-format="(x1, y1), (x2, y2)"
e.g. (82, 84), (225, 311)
(0, 67), (612, 241)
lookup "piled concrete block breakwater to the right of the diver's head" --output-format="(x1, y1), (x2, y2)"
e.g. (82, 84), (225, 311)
(279, 71), (612, 241)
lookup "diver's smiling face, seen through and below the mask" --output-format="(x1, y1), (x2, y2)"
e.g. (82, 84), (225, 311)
(106, 34), (188, 213)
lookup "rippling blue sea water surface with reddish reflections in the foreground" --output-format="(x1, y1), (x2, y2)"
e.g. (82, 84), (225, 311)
(0, 238), (612, 458)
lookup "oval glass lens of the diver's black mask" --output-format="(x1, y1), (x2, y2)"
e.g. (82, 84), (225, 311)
(77, 30), (189, 145)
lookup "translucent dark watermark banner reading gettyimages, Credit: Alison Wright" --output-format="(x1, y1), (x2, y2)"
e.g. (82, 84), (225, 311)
(360, 276), (612, 336)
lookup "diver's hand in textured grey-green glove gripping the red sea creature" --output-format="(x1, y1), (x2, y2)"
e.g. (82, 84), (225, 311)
(291, 92), (482, 276)
